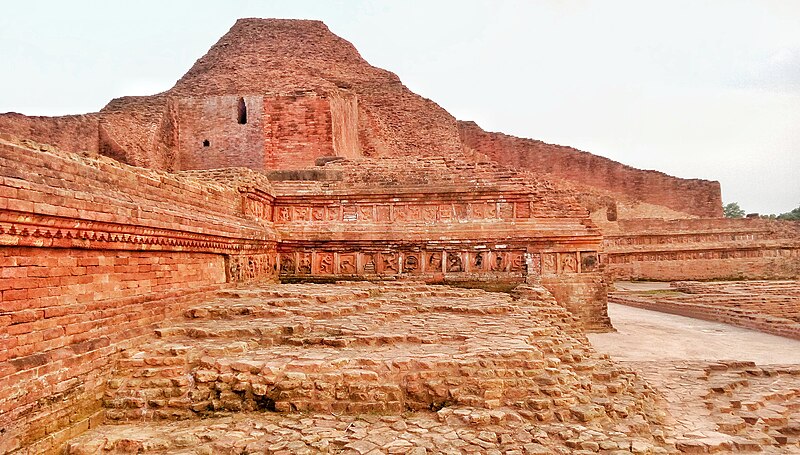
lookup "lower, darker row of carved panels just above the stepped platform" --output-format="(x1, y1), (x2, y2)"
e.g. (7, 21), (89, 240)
(279, 251), (598, 275)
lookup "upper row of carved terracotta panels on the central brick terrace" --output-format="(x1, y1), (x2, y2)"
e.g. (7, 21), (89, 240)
(245, 199), (532, 223)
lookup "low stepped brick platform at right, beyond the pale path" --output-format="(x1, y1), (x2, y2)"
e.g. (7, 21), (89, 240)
(609, 281), (800, 339)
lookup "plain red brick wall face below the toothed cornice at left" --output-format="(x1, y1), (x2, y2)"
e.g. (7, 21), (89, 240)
(0, 251), (225, 452)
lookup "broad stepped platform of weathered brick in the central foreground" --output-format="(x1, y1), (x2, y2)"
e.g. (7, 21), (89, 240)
(68, 282), (670, 454)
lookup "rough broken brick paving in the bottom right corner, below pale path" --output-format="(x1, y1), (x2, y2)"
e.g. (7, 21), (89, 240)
(626, 360), (800, 454)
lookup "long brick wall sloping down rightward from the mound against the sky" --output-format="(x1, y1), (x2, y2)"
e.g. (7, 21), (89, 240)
(459, 122), (722, 217)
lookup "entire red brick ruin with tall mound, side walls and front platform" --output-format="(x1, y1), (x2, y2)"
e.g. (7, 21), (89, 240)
(0, 19), (800, 453)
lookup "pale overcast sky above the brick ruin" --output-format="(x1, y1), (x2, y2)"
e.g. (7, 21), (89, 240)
(0, 0), (800, 213)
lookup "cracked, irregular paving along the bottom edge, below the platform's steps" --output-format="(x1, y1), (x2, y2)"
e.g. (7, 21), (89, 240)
(67, 408), (669, 455)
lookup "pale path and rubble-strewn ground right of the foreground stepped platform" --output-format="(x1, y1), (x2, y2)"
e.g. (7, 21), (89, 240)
(589, 302), (800, 453)
